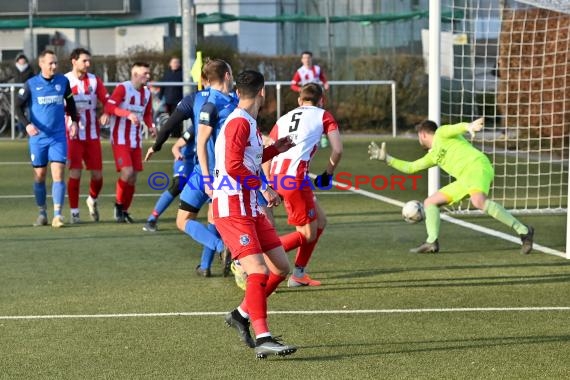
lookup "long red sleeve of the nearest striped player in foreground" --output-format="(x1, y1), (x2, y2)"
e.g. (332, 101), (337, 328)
(224, 117), (261, 189)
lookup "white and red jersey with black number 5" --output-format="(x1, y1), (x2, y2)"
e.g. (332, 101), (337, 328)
(269, 106), (338, 179)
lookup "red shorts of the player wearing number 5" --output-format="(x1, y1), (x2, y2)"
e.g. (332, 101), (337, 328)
(278, 182), (317, 226)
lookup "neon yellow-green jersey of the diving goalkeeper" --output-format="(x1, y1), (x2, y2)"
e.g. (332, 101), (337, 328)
(388, 123), (490, 178)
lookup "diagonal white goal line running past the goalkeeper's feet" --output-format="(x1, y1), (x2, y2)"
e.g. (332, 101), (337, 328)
(318, 174), (566, 258)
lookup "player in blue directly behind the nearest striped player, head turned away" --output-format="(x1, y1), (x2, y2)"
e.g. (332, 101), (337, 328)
(176, 59), (237, 277)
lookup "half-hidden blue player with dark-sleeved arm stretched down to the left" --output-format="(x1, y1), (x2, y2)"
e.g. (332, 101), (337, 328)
(143, 90), (210, 232)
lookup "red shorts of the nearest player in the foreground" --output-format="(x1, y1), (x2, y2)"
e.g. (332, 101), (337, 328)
(215, 215), (281, 259)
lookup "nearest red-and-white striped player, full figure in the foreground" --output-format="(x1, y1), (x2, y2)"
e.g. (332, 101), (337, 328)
(212, 70), (297, 358)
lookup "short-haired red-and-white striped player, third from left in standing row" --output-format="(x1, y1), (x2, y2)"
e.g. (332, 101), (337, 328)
(105, 62), (156, 223)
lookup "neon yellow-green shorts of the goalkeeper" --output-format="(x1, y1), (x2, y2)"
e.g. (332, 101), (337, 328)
(439, 160), (495, 204)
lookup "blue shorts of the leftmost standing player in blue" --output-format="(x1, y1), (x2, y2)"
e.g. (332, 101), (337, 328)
(28, 133), (67, 168)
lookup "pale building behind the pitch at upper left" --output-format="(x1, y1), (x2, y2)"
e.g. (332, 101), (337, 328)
(0, 0), (290, 59)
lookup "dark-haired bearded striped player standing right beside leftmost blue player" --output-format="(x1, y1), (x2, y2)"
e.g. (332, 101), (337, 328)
(65, 48), (109, 223)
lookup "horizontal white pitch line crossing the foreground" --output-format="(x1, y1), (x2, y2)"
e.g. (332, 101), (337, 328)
(0, 306), (570, 320)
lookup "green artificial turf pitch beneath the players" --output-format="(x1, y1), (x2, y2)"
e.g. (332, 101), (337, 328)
(0, 138), (570, 379)
